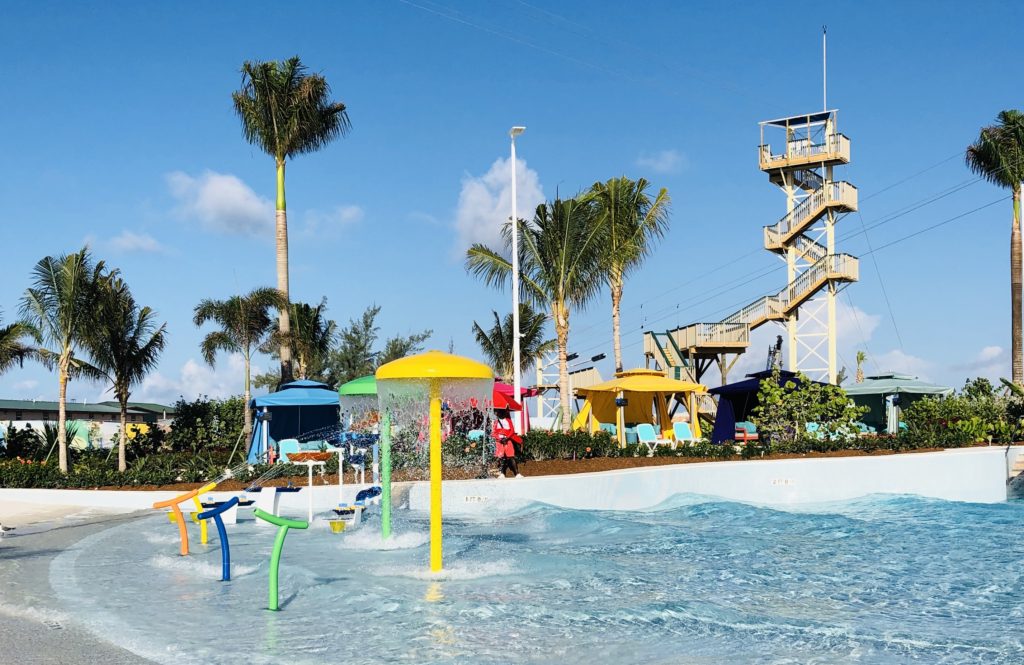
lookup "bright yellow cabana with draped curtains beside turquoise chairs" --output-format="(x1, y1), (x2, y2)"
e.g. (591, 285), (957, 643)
(572, 369), (708, 446)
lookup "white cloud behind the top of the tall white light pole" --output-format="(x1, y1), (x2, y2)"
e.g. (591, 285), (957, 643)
(454, 158), (544, 256)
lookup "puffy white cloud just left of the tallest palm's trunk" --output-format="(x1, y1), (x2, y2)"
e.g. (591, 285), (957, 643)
(167, 171), (274, 238)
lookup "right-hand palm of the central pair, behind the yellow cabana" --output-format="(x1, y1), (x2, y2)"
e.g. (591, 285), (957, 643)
(591, 176), (672, 372)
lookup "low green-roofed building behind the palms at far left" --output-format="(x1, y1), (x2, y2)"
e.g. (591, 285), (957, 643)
(0, 400), (175, 448)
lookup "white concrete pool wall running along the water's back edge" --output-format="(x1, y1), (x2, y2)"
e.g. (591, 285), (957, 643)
(0, 446), (1024, 514)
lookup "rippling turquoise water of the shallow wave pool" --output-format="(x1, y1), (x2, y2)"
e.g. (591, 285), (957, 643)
(51, 497), (1024, 664)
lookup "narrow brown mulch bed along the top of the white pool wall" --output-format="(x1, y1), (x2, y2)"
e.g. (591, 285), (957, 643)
(96, 448), (943, 492)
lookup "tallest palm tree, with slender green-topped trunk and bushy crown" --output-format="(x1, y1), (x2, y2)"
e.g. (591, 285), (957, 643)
(231, 56), (350, 381)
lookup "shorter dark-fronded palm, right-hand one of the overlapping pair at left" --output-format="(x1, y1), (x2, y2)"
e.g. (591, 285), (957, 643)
(87, 278), (167, 472)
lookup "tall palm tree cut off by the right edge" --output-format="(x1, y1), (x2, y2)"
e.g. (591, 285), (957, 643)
(967, 110), (1024, 385)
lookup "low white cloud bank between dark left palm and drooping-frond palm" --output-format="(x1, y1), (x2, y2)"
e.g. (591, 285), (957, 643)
(132, 354), (260, 404)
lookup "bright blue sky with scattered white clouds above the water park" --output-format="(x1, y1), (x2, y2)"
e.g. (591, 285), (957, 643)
(0, 0), (1024, 401)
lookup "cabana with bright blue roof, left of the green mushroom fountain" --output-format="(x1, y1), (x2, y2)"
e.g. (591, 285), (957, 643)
(248, 380), (340, 464)
